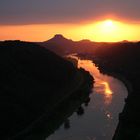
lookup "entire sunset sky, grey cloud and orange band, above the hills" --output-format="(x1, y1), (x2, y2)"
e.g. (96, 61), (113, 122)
(0, 0), (140, 41)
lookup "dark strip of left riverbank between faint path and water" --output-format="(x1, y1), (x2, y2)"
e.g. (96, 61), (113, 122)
(10, 69), (94, 140)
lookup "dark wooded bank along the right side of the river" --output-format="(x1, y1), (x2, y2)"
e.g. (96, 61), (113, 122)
(79, 52), (140, 140)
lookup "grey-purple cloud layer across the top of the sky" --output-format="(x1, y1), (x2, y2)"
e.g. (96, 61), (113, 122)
(0, 0), (140, 25)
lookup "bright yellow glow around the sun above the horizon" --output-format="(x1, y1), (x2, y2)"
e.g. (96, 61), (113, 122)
(84, 19), (134, 42)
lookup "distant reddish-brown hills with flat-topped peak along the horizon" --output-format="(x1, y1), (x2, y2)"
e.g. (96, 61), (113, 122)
(39, 34), (139, 55)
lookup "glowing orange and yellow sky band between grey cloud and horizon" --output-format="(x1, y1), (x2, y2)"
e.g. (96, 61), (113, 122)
(0, 19), (140, 42)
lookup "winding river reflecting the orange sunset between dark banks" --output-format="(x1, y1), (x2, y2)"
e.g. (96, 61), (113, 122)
(46, 57), (128, 140)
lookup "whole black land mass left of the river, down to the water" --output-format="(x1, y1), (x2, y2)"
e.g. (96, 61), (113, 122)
(0, 41), (93, 140)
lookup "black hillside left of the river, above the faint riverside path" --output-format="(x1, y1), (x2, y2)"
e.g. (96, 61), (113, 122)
(0, 41), (93, 140)
